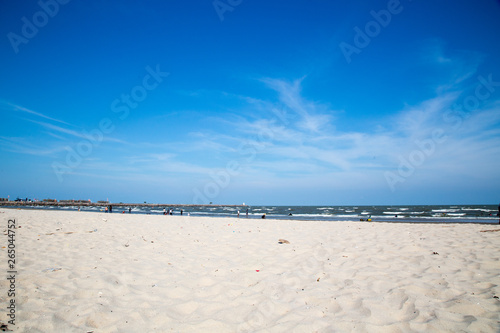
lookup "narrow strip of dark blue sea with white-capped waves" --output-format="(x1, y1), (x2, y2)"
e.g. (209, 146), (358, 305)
(11, 205), (499, 223)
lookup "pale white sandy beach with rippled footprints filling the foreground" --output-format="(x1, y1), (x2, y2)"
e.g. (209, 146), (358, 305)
(0, 209), (500, 332)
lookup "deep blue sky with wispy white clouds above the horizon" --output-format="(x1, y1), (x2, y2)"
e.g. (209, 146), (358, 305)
(0, 0), (500, 205)
